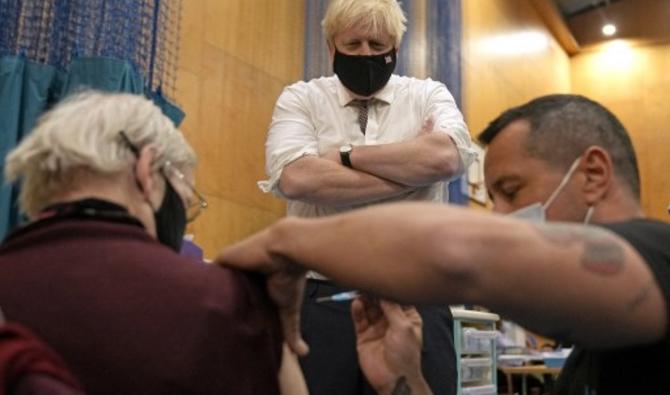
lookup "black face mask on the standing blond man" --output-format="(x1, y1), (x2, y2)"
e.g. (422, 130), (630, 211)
(333, 48), (396, 97)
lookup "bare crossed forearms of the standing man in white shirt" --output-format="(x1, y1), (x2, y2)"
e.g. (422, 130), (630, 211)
(279, 124), (460, 206)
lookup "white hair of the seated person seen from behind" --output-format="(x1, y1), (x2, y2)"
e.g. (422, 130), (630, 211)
(5, 91), (196, 217)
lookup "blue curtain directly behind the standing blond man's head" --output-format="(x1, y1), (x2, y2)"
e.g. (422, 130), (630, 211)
(304, 0), (468, 204)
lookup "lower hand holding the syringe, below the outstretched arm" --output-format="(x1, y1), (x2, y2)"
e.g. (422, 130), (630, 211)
(351, 298), (430, 394)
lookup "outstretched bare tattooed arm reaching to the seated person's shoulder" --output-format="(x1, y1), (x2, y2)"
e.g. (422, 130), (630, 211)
(220, 203), (668, 347)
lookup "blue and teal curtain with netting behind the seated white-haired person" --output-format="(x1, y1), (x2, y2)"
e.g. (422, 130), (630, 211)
(0, 0), (184, 238)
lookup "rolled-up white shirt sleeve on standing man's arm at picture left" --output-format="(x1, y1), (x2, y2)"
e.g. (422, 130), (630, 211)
(258, 86), (319, 197)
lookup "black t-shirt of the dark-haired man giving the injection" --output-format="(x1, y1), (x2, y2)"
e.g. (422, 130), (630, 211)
(555, 219), (670, 395)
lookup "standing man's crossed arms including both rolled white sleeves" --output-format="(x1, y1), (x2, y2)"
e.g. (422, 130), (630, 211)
(266, 84), (470, 206)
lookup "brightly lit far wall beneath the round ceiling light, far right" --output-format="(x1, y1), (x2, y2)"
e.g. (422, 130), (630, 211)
(571, 41), (670, 221)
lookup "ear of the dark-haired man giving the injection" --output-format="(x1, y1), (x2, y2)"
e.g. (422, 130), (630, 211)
(580, 145), (613, 205)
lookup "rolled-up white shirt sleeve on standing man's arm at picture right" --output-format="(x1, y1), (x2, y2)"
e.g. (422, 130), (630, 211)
(426, 82), (477, 178)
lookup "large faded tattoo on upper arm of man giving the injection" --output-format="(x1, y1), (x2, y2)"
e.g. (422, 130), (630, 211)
(537, 224), (625, 276)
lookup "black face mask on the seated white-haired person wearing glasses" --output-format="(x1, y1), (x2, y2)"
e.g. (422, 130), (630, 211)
(154, 180), (186, 253)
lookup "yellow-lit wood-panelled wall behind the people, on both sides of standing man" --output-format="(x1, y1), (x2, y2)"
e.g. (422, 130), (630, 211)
(172, 0), (670, 257)
